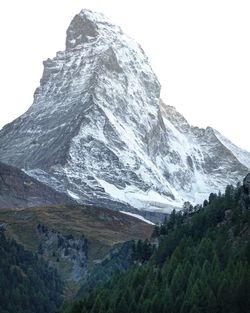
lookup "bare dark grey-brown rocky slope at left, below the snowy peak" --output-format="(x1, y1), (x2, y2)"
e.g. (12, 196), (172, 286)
(0, 163), (74, 209)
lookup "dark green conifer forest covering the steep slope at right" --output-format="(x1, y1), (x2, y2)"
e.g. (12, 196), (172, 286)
(67, 186), (250, 313)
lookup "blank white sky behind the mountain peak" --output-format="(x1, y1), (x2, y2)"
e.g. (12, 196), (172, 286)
(0, 0), (250, 151)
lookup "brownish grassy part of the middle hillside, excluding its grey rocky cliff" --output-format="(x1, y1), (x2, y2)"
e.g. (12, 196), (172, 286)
(0, 205), (153, 296)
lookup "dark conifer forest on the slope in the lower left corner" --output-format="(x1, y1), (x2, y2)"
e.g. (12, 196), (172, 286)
(0, 230), (63, 313)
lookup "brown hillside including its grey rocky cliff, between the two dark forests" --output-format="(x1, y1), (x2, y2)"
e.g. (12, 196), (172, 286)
(0, 205), (153, 297)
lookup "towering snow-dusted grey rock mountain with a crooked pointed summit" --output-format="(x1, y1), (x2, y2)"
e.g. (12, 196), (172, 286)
(0, 10), (250, 212)
